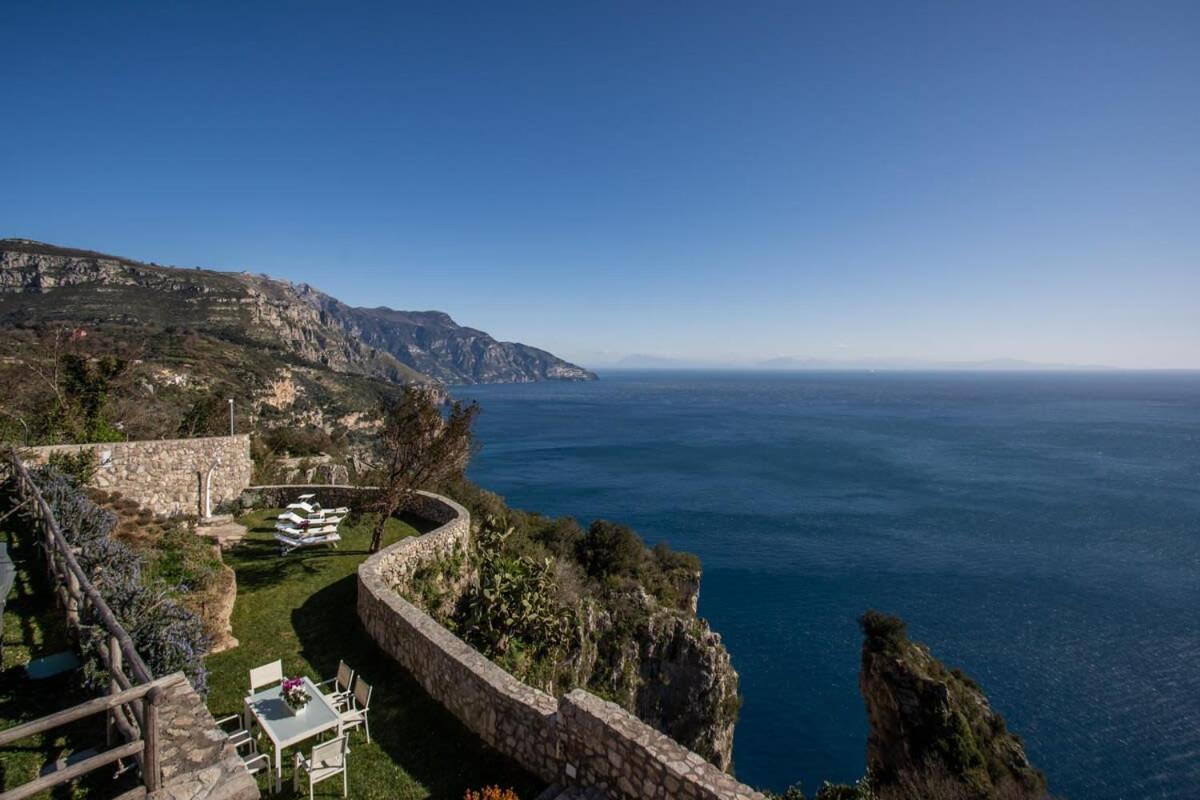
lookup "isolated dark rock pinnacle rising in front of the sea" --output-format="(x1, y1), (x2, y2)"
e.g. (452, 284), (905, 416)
(859, 612), (1046, 800)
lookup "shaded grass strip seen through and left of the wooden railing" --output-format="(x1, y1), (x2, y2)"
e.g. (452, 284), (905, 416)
(0, 510), (127, 800)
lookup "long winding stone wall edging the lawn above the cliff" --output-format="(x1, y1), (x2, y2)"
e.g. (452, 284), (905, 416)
(355, 487), (764, 800)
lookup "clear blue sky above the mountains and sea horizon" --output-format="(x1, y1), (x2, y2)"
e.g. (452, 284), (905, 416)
(0, 0), (1200, 367)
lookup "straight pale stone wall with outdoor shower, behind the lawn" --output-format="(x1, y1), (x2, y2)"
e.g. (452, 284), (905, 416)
(25, 434), (253, 517)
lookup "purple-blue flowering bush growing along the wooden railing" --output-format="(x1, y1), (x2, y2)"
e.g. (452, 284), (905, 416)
(32, 467), (209, 696)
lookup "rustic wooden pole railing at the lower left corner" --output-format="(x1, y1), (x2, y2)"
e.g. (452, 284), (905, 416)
(0, 450), (166, 800)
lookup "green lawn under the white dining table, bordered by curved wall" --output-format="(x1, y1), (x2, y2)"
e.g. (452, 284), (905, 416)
(208, 511), (544, 800)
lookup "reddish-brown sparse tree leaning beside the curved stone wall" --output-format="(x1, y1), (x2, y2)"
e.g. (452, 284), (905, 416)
(371, 386), (479, 553)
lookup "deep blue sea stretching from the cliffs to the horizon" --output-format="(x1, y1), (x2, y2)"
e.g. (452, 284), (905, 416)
(454, 372), (1200, 800)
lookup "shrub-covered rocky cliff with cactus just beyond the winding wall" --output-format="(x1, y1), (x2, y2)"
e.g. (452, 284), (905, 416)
(395, 494), (740, 771)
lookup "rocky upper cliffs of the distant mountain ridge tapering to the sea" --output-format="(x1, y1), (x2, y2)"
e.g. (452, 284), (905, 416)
(0, 240), (595, 383)
